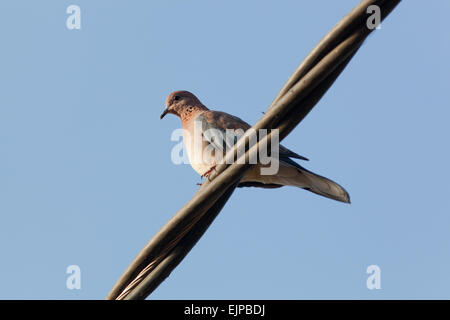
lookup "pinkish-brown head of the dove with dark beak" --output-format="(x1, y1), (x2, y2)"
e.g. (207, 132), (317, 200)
(160, 91), (206, 119)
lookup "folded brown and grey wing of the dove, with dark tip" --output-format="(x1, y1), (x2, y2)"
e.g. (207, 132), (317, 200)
(196, 110), (308, 161)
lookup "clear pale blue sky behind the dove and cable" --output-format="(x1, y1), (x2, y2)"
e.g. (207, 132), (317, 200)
(0, 0), (450, 299)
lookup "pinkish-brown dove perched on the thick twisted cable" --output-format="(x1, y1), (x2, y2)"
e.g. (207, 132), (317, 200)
(161, 91), (350, 203)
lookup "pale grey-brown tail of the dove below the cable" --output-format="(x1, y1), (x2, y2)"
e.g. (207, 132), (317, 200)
(291, 168), (350, 203)
